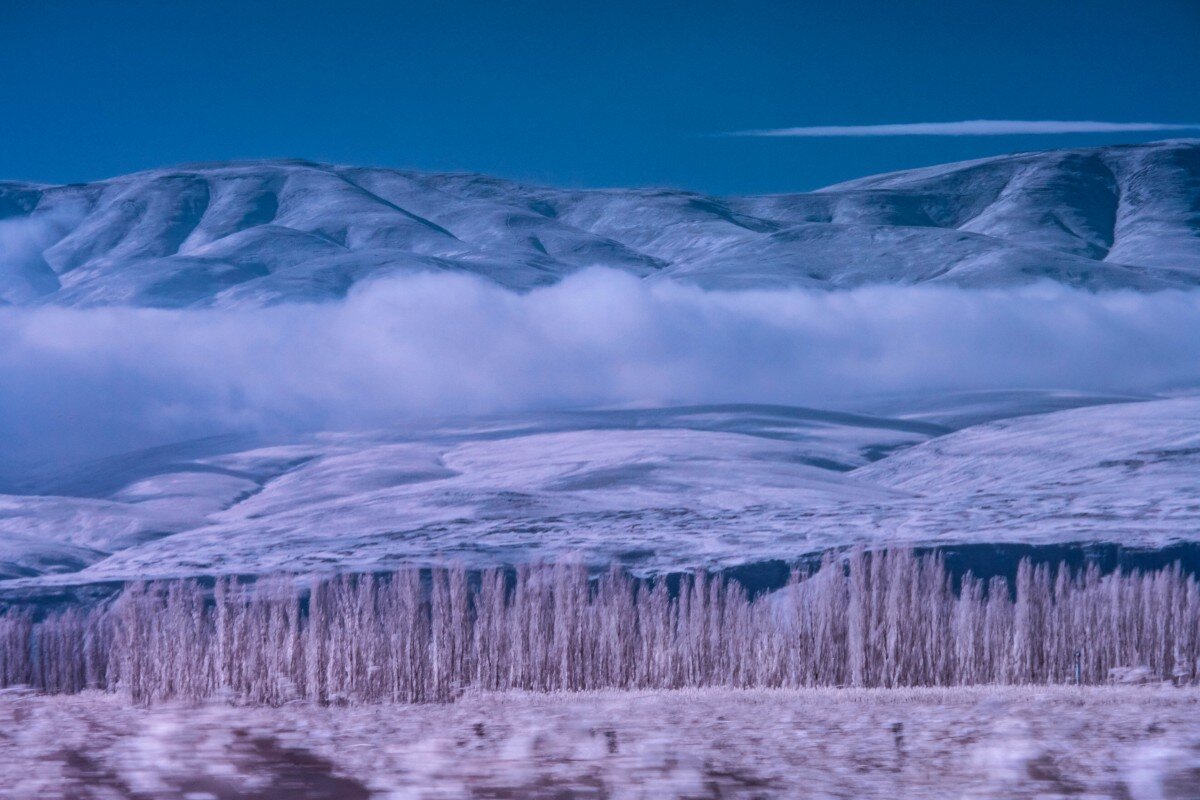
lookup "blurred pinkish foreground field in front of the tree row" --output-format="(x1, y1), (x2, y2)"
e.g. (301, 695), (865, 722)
(0, 687), (1200, 800)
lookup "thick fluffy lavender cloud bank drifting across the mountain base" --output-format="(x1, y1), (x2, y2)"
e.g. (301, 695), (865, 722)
(0, 270), (1200, 458)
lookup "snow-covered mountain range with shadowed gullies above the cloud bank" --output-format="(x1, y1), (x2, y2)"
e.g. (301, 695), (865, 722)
(0, 139), (1200, 307)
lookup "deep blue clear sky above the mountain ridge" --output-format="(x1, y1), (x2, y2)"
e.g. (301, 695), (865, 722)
(0, 0), (1200, 193)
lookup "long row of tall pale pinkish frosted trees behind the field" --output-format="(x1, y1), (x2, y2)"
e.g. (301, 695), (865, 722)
(0, 551), (1200, 704)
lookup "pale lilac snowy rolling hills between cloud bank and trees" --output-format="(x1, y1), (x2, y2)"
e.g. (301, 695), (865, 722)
(0, 392), (1200, 590)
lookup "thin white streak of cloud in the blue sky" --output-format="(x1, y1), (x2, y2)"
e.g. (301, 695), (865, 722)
(726, 120), (1200, 137)
